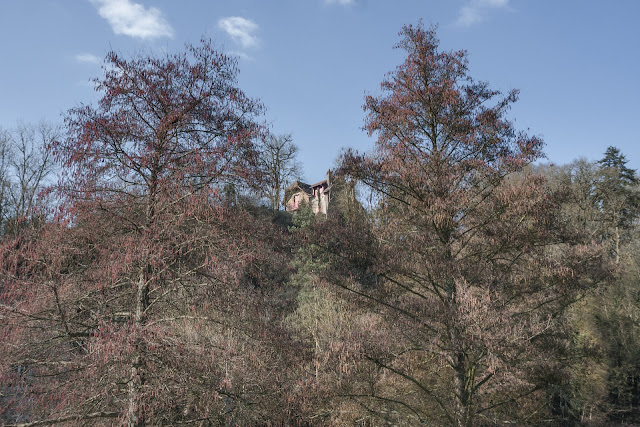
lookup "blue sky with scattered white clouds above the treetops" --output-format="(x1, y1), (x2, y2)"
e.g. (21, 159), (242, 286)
(0, 0), (640, 182)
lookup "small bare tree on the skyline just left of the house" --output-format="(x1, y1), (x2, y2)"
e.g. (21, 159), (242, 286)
(260, 134), (301, 211)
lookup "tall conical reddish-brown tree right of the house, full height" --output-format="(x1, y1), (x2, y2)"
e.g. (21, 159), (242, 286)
(337, 25), (606, 426)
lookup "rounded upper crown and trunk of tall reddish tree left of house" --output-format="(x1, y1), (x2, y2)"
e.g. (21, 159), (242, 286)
(59, 43), (261, 425)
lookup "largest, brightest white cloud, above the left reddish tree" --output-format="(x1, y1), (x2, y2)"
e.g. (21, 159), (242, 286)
(90, 0), (173, 39)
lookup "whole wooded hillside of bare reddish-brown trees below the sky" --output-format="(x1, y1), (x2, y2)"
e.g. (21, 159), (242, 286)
(0, 24), (640, 426)
